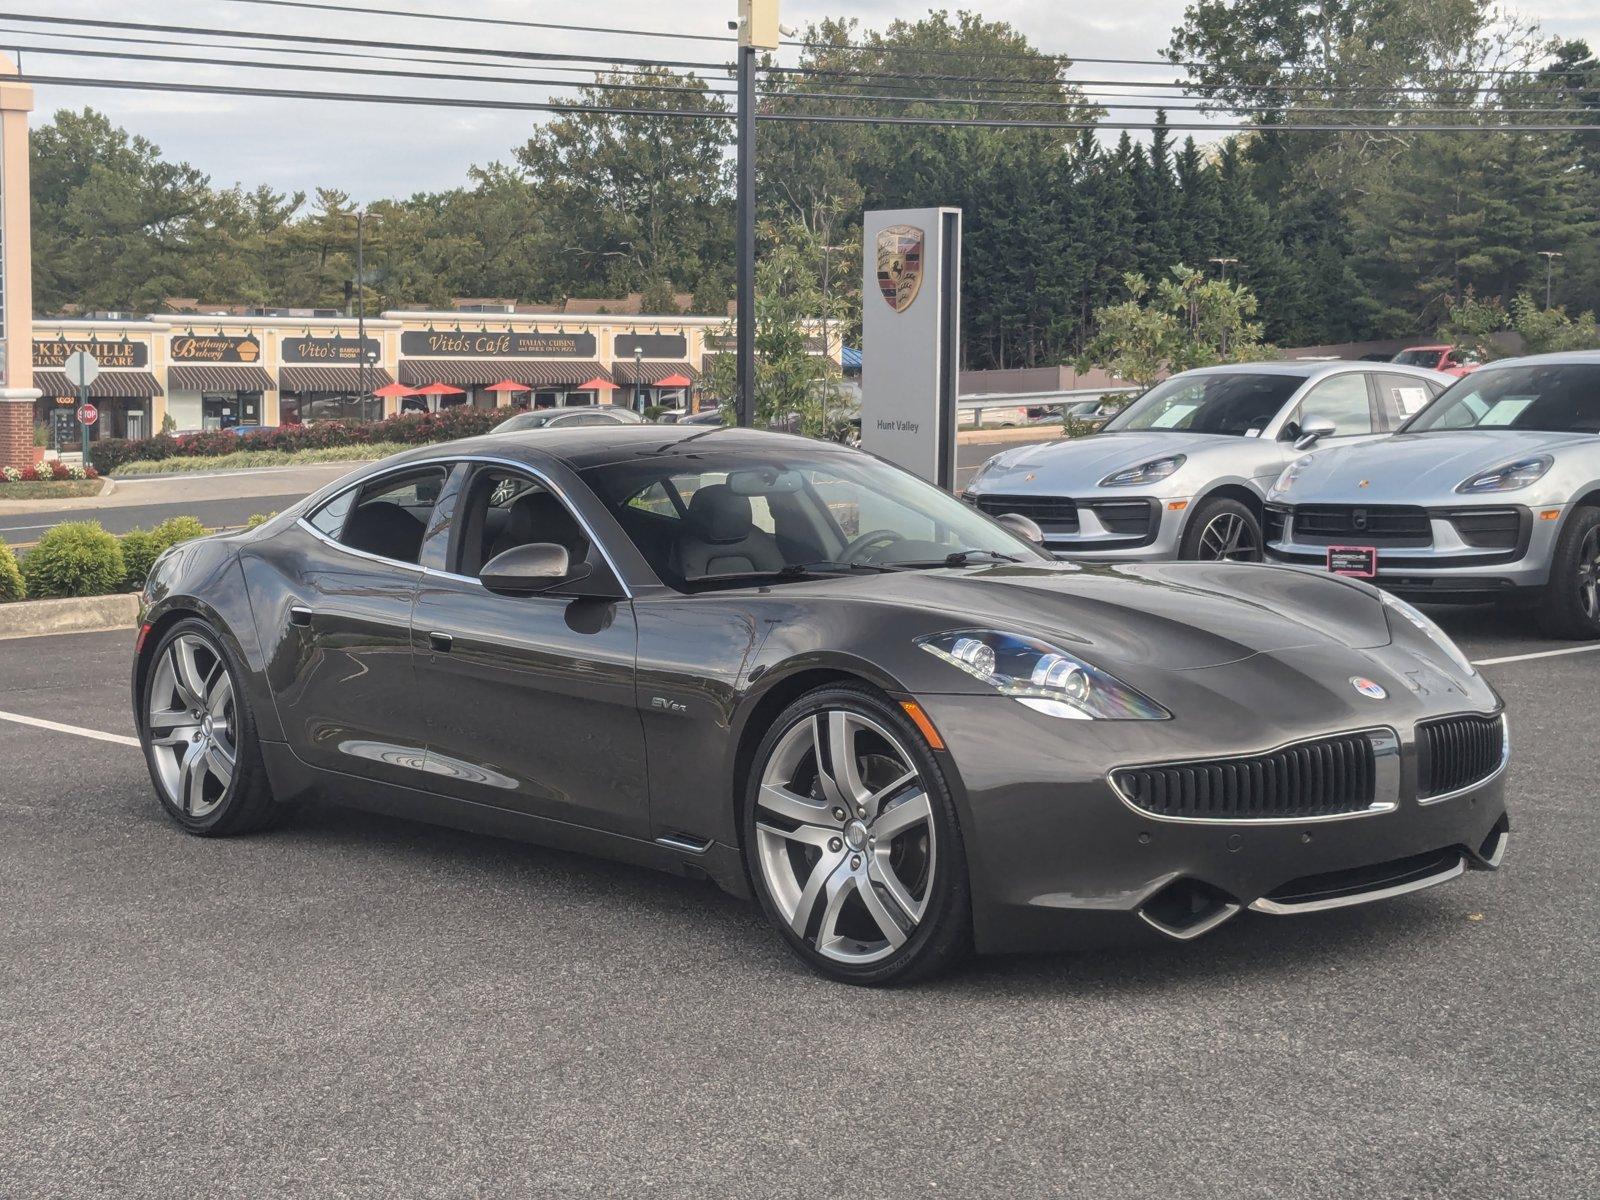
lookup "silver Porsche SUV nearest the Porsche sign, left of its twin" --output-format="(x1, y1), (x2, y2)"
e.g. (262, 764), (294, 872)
(963, 362), (1453, 562)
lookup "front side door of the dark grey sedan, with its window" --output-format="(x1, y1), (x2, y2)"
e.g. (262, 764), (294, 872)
(413, 467), (650, 837)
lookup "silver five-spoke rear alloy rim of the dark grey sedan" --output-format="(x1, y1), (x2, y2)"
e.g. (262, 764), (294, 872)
(146, 634), (238, 819)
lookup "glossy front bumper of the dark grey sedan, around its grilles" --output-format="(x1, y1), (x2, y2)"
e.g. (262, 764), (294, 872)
(920, 664), (1510, 952)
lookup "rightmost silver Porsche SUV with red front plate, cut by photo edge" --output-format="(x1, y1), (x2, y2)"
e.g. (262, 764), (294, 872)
(1267, 352), (1600, 638)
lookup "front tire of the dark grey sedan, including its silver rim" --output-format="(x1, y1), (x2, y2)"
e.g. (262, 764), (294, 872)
(744, 685), (973, 986)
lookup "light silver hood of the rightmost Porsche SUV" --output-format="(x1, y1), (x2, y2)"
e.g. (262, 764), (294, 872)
(1272, 429), (1594, 504)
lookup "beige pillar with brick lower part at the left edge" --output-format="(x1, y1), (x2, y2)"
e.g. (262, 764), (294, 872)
(0, 54), (38, 467)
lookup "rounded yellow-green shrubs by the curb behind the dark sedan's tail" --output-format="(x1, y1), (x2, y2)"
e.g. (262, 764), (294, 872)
(0, 517), (228, 602)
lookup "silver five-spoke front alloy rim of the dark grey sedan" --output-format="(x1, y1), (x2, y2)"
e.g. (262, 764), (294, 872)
(755, 709), (934, 965)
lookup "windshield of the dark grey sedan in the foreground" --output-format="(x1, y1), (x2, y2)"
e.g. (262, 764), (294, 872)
(582, 441), (1050, 592)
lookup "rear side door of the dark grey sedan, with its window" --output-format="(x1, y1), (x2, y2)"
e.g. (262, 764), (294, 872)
(243, 466), (446, 787)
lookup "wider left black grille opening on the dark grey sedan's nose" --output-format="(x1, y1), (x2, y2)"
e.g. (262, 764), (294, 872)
(1112, 733), (1378, 821)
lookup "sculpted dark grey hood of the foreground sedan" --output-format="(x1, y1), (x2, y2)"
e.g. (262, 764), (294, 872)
(800, 563), (1389, 670)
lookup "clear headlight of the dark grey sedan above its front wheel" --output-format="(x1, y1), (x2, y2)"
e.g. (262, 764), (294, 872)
(917, 629), (1171, 722)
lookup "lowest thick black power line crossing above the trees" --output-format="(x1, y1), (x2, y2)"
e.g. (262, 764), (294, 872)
(13, 75), (1600, 133)
